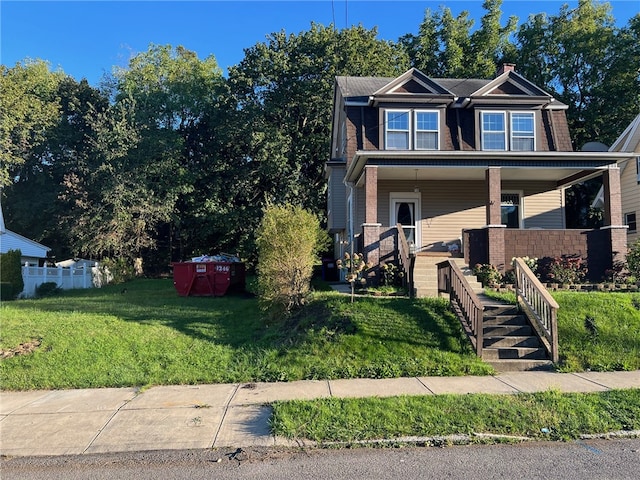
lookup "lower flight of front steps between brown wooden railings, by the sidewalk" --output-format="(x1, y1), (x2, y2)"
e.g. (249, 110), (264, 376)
(482, 299), (553, 372)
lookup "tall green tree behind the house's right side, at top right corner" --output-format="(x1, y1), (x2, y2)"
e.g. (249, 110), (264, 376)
(516, 0), (640, 148)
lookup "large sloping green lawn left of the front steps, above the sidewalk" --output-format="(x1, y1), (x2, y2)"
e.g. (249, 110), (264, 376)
(0, 280), (491, 390)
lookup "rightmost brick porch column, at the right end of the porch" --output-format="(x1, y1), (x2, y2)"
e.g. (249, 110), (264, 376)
(602, 165), (627, 264)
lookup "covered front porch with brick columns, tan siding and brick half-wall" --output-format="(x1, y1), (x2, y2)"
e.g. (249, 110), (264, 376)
(354, 159), (627, 292)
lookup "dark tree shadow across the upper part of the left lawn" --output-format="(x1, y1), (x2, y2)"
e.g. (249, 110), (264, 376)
(6, 280), (466, 353)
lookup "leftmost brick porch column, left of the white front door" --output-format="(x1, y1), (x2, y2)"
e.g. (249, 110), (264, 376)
(362, 165), (381, 285)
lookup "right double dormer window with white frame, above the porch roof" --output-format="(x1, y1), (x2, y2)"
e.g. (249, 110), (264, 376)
(480, 112), (535, 152)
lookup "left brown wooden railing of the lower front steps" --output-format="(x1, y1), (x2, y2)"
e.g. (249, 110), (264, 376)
(437, 260), (483, 358)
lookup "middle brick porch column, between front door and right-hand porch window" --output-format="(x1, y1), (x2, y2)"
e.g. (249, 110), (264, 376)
(485, 167), (505, 272)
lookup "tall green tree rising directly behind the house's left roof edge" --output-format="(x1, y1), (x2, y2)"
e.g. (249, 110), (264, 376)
(229, 24), (408, 229)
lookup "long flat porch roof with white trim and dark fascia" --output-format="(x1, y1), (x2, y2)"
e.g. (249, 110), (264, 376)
(345, 150), (633, 188)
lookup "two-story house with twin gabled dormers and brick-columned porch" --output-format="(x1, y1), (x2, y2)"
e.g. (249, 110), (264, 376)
(326, 64), (628, 295)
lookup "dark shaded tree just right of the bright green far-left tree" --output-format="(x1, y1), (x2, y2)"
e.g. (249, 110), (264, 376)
(5, 77), (108, 258)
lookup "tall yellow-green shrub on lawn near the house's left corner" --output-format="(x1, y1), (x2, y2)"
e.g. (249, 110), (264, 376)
(256, 204), (327, 317)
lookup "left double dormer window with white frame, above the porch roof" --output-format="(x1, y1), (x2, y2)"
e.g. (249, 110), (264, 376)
(384, 110), (440, 150)
